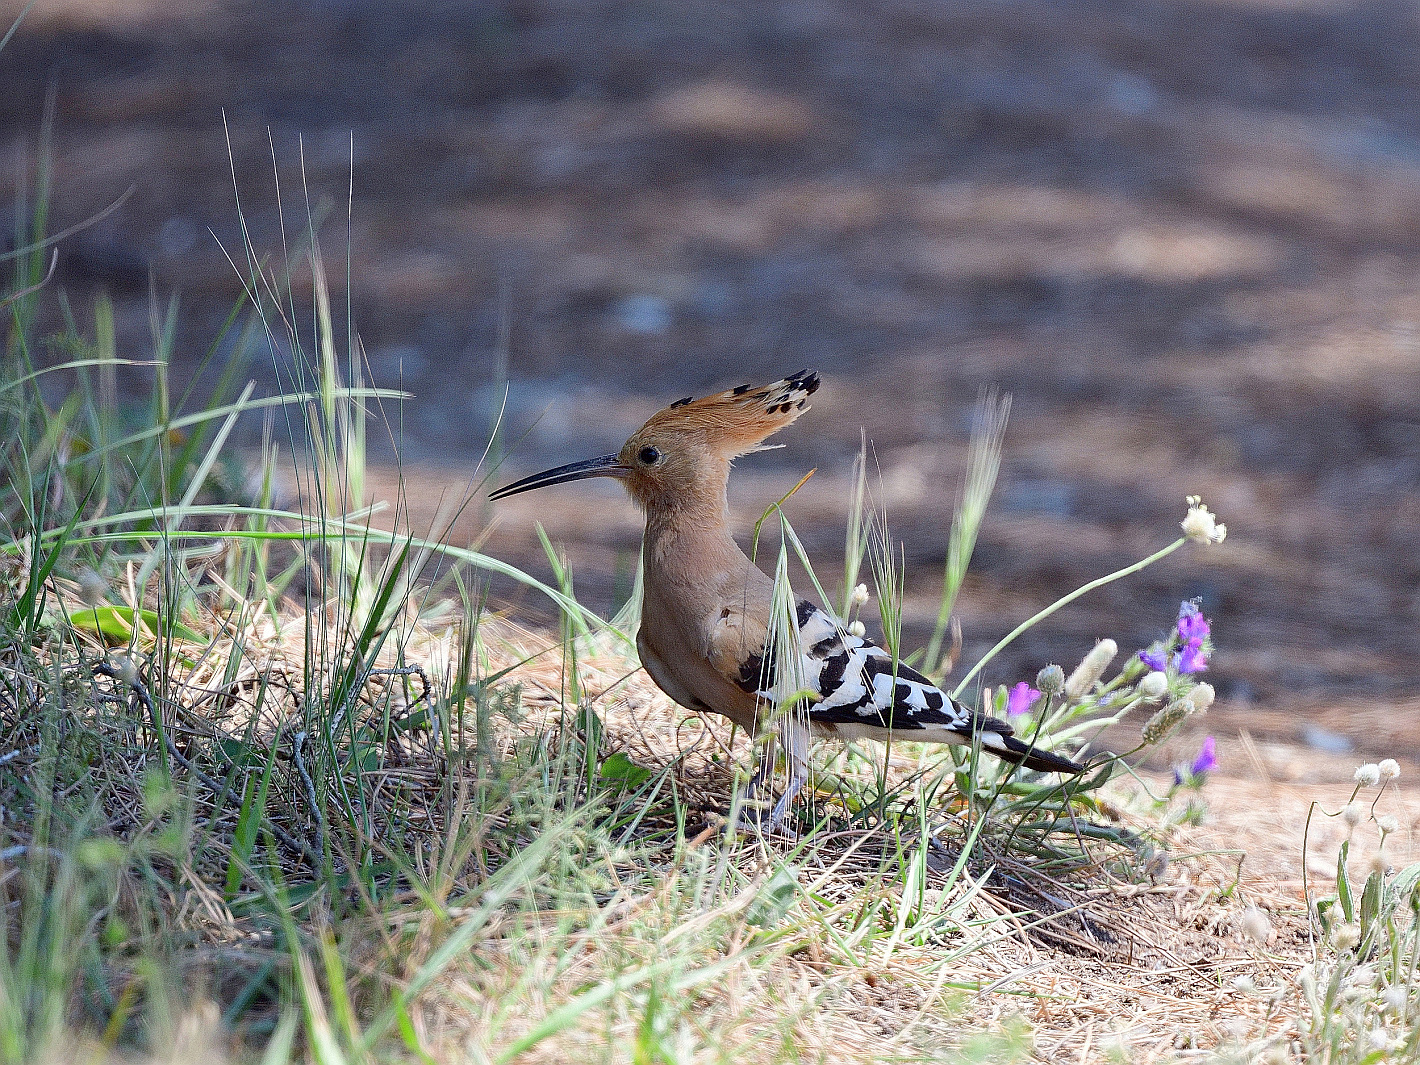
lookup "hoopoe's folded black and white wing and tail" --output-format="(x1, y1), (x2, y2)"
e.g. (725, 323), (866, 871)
(747, 599), (1083, 772)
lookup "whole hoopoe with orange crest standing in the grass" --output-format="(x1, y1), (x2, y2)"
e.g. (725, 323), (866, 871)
(490, 371), (1083, 826)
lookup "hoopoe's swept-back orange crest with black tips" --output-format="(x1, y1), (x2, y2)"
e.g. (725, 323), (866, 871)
(638, 369), (819, 456)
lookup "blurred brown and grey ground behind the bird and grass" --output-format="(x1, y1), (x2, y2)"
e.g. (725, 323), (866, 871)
(0, 0), (1420, 746)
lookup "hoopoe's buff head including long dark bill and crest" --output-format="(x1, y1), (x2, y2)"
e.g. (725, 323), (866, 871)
(490, 371), (819, 510)
